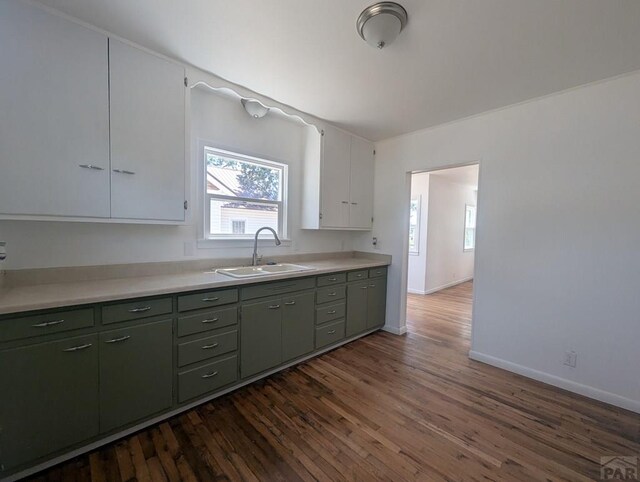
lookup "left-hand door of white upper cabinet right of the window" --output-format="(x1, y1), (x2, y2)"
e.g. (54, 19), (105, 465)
(320, 127), (351, 228)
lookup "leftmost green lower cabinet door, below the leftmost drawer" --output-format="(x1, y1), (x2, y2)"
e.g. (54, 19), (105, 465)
(0, 335), (99, 470)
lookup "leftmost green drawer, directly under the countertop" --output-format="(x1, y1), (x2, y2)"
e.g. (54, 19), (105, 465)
(0, 308), (94, 341)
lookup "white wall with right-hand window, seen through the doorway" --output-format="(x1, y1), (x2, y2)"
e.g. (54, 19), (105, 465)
(424, 174), (476, 293)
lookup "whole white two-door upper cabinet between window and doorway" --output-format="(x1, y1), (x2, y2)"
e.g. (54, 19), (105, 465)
(302, 126), (374, 230)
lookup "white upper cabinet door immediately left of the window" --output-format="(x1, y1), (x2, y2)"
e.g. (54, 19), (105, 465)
(109, 39), (185, 221)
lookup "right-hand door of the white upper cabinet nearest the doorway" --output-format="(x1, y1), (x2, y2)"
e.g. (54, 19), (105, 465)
(349, 137), (373, 229)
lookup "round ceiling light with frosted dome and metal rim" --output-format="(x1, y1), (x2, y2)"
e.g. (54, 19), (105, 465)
(356, 2), (408, 49)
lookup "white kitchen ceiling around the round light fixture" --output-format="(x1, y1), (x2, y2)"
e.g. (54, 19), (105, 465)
(36, 0), (640, 140)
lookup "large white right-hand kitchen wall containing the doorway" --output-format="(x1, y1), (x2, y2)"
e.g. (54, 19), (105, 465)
(357, 69), (640, 411)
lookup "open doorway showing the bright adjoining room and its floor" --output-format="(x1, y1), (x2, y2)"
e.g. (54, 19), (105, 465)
(407, 163), (479, 348)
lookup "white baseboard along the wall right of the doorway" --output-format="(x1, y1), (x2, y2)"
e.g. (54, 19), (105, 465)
(469, 350), (640, 413)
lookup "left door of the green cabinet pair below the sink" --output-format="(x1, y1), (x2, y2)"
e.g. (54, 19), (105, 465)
(240, 298), (282, 378)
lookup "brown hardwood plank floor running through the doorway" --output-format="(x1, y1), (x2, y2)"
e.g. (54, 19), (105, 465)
(26, 283), (640, 482)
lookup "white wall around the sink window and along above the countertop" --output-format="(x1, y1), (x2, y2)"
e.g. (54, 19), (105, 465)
(0, 69), (353, 269)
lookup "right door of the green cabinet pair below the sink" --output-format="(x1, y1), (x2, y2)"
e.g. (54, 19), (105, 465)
(282, 292), (315, 362)
